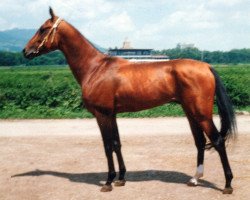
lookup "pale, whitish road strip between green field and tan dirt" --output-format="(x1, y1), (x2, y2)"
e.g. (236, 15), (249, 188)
(0, 115), (250, 137)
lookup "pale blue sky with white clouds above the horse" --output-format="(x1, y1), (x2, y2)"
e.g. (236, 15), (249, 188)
(0, 0), (250, 51)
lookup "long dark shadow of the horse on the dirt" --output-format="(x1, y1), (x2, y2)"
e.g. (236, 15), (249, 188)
(11, 170), (222, 191)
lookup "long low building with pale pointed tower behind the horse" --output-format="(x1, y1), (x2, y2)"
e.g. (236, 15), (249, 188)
(108, 39), (169, 62)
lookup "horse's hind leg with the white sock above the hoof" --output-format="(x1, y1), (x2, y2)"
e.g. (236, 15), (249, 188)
(187, 117), (206, 186)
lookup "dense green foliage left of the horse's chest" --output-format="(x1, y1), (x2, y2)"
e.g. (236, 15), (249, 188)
(0, 67), (87, 118)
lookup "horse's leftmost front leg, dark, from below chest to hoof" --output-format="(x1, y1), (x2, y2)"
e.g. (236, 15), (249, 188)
(95, 112), (116, 192)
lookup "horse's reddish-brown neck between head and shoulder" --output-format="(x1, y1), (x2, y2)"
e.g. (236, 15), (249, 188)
(59, 24), (104, 85)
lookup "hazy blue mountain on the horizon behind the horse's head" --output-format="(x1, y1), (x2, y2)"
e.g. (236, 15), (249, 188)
(0, 28), (107, 52)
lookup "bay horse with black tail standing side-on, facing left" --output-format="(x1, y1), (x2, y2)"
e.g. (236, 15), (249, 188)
(23, 8), (236, 194)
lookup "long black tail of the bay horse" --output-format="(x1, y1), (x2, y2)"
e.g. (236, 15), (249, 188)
(211, 68), (237, 140)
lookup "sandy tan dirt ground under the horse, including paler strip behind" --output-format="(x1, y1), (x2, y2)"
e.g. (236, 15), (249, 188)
(0, 116), (250, 200)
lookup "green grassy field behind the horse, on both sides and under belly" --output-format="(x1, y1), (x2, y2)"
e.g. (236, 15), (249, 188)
(0, 64), (250, 119)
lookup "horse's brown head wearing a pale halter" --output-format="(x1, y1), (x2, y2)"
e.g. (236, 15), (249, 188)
(23, 8), (62, 59)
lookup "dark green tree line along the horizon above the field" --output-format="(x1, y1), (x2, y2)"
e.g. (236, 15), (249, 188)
(0, 47), (250, 66)
